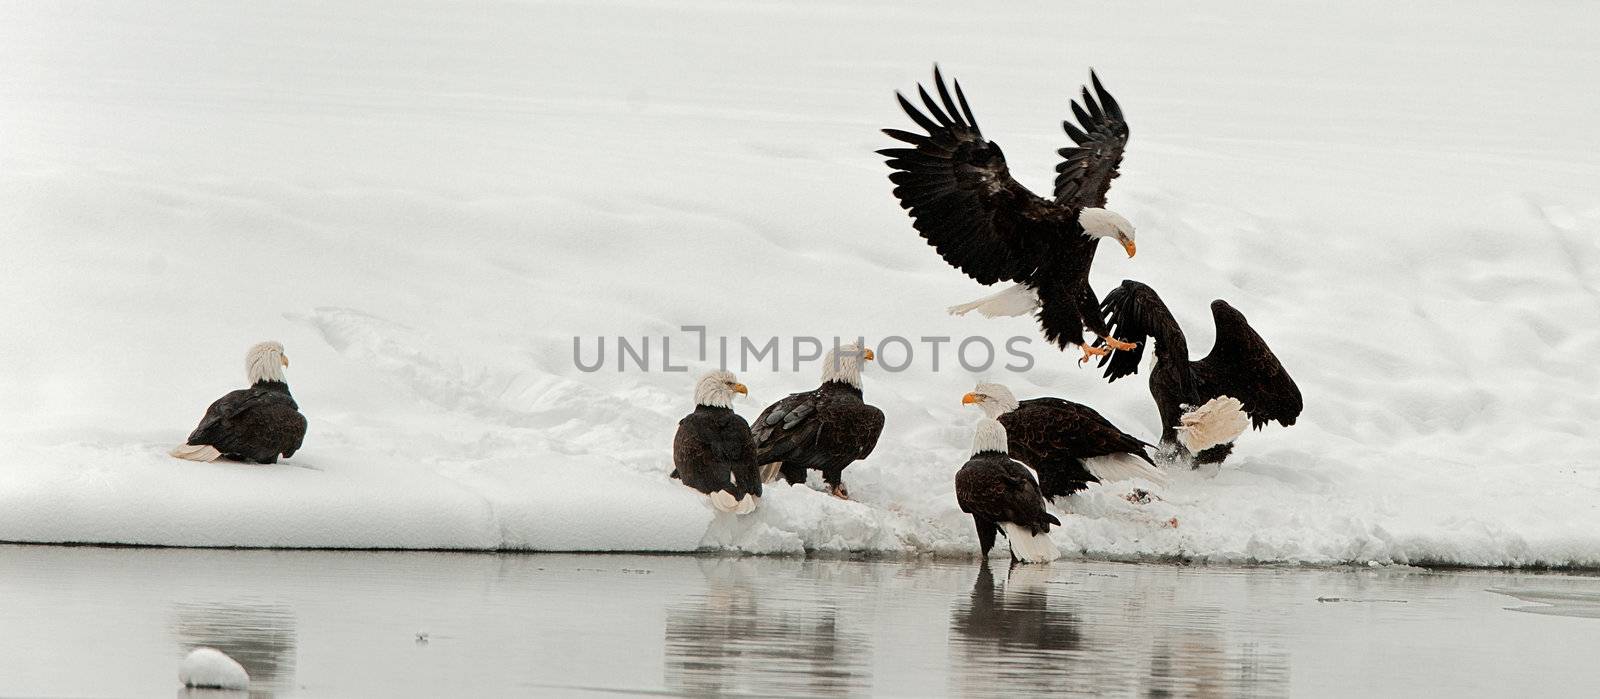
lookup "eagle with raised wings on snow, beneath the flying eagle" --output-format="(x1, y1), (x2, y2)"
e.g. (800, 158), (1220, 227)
(1099, 280), (1304, 464)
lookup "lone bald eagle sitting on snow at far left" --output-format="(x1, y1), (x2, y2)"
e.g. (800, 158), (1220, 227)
(173, 342), (306, 464)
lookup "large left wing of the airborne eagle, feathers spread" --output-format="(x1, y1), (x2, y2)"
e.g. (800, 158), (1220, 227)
(878, 67), (1077, 285)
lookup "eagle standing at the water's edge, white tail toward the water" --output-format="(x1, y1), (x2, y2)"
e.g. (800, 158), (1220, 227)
(955, 417), (1061, 563)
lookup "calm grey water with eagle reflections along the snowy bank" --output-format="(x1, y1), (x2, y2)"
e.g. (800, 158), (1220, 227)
(0, 547), (1600, 696)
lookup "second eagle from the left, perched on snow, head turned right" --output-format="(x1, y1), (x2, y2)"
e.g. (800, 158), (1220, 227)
(672, 369), (762, 515)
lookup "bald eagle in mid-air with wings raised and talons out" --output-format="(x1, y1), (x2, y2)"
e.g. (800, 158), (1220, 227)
(878, 67), (1136, 363)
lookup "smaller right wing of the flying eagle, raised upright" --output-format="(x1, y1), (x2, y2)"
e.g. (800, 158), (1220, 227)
(1056, 70), (1128, 208)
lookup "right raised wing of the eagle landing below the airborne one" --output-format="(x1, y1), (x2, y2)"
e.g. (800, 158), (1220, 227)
(1194, 299), (1304, 429)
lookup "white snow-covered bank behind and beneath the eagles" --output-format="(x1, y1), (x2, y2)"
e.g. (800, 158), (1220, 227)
(0, 0), (1600, 566)
